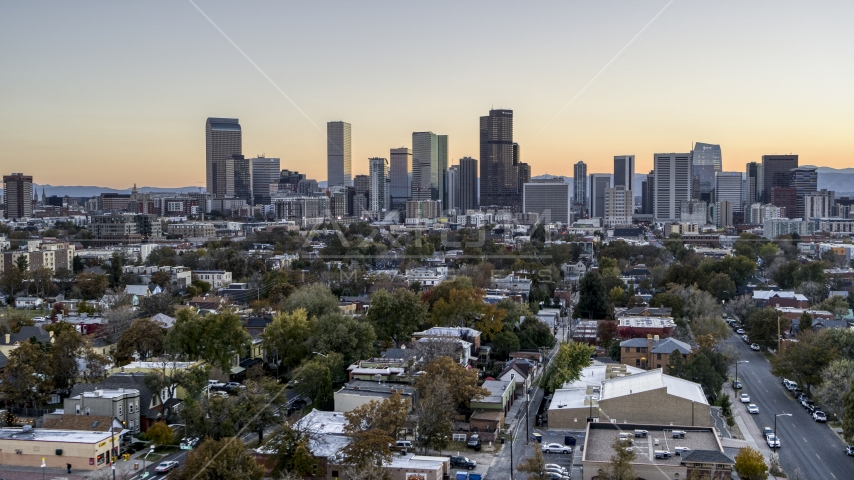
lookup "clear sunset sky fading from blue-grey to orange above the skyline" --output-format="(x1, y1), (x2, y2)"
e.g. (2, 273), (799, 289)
(0, 0), (854, 188)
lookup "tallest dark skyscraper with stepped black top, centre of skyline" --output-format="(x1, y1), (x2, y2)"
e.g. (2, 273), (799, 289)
(480, 110), (521, 207)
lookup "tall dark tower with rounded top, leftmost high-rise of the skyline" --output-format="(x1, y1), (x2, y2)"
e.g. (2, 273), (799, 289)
(205, 117), (243, 197)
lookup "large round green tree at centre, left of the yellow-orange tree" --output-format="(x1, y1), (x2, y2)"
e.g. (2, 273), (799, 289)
(367, 288), (427, 347)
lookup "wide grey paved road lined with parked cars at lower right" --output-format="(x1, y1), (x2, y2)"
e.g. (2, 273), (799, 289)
(728, 335), (854, 480)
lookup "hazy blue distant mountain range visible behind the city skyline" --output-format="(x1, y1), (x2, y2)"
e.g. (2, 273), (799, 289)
(5, 167), (854, 197)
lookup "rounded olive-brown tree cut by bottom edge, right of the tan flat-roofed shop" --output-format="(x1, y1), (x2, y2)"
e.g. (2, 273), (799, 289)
(169, 437), (264, 480)
